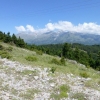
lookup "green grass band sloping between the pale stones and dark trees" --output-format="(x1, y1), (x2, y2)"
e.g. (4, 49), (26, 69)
(0, 43), (100, 90)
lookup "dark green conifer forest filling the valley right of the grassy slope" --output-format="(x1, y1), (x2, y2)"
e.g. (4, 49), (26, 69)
(38, 43), (100, 70)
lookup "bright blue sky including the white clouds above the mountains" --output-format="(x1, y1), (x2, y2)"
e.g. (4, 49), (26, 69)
(0, 0), (100, 34)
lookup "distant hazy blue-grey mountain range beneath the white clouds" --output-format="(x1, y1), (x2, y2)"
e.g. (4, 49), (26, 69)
(17, 31), (100, 45)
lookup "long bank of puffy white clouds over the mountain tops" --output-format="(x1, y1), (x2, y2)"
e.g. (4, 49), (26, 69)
(15, 21), (100, 34)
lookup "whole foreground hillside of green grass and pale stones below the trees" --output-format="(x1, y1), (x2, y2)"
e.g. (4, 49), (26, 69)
(0, 43), (100, 100)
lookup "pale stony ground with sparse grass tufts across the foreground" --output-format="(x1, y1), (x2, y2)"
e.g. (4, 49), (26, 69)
(0, 58), (100, 100)
